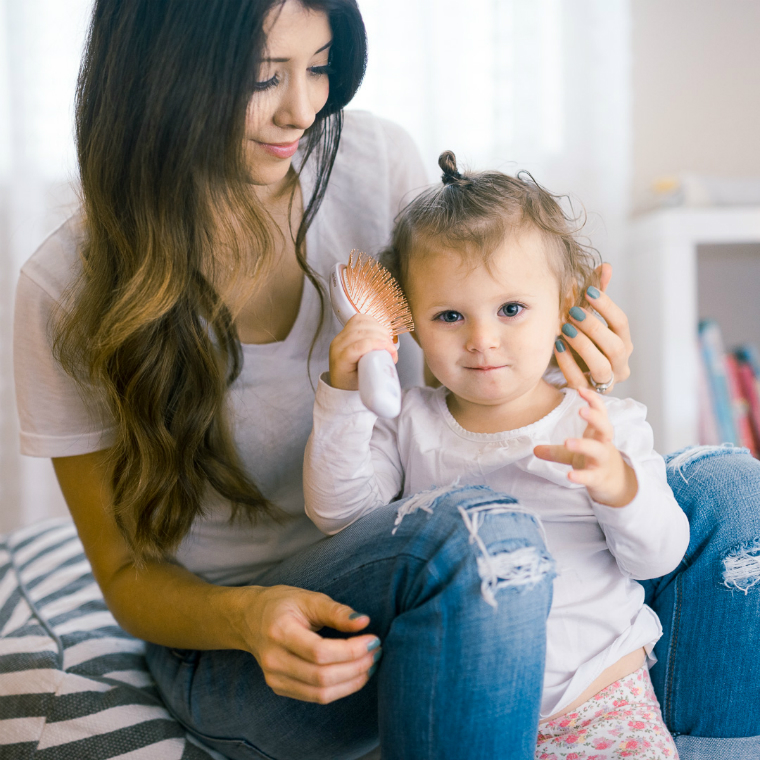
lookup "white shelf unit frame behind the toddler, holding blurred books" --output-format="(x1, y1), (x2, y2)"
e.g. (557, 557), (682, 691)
(629, 206), (760, 453)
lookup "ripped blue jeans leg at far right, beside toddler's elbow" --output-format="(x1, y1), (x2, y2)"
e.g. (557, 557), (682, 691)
(643, 446), (760, 760)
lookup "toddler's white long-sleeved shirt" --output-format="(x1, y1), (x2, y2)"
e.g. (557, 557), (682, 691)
(304, 380), (689, 717)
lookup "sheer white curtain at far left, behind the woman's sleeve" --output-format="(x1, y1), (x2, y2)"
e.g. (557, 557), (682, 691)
(0, 0), (91, 531)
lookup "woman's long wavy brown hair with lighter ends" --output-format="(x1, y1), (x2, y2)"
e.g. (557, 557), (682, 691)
(54, 0), (366, 561)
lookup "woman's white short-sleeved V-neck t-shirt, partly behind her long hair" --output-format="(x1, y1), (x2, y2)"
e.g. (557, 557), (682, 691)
(14, 111), (427, 584)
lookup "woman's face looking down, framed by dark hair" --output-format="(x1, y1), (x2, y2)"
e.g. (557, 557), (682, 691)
(245, 0), (332, 189)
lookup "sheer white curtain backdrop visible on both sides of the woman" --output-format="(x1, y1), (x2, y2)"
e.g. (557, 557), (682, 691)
(0, 0), (631, 530)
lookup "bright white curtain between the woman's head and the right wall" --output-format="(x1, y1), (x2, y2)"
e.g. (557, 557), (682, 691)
(351, 0), (632, 274)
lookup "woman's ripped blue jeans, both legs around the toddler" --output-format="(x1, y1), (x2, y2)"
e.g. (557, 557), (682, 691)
(148, 448), (760, 760)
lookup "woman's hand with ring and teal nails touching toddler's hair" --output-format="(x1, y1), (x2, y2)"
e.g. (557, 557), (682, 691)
(554, 264), (633, 389)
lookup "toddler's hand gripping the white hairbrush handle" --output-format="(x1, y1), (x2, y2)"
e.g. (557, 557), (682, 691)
(330, 314), (398, 391)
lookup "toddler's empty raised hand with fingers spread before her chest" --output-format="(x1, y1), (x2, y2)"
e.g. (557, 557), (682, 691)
(533, 388), (638, 507)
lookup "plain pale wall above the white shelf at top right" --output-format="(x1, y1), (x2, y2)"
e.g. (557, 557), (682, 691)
(631, 0), (760, 210)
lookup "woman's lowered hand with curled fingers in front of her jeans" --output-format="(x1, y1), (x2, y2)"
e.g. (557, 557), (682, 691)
(240, 586), (382, 704)
